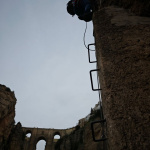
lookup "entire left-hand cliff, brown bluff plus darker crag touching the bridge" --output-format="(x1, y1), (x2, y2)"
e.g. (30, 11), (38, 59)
(0, 85), (24, 150)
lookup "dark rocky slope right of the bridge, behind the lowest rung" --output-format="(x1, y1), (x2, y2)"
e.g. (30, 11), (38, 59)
(55, 110), (106, 150)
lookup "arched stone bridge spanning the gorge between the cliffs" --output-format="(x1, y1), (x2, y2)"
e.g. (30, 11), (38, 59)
(23, 127), (75, 150)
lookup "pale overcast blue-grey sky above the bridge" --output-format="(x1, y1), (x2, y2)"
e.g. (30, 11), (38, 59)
(0, 0), (98, 129)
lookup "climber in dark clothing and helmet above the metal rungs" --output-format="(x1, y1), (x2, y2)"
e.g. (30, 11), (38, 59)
(67, 0), (93, 22)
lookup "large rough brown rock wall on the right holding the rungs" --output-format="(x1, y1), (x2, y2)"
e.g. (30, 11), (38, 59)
(93, 6), (150, 150)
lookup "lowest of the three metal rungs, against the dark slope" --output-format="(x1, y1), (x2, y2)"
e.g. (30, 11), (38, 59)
(91, 119), (107, 142)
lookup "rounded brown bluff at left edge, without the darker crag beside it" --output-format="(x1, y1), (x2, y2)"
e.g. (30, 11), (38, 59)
(0, 85), (16, 150)
